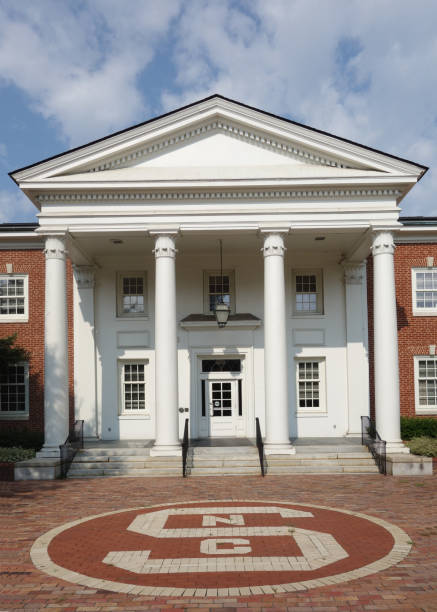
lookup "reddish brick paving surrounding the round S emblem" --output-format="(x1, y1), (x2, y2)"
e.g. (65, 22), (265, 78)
(0, 475), (437, 612)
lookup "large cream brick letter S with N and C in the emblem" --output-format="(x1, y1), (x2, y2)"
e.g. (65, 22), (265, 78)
(103, 506), (349, 574)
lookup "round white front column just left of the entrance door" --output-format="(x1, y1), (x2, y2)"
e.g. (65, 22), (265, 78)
(150, 235), (182, 456)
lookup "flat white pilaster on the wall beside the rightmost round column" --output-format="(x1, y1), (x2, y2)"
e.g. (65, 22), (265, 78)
(343, 262), (369, 436)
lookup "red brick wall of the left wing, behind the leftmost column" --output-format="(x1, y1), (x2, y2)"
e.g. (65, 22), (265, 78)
(0, 250), (74, 432)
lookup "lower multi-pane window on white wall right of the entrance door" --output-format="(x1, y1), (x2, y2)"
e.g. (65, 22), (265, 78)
(296, 359), (326, 413)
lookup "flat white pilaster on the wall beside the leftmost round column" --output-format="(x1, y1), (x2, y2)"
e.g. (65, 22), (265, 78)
(73, 266), (97, 438)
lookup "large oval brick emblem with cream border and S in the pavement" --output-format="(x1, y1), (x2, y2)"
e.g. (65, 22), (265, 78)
(31, 501), (411, 597)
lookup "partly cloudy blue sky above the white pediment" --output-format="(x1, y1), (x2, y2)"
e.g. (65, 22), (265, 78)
(0, 0), (437, 223)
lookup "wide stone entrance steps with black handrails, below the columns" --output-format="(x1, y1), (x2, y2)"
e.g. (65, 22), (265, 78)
(67, 438), (378, 478)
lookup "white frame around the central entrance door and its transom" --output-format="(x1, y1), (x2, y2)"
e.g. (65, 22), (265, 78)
(190, 347), (255, 439)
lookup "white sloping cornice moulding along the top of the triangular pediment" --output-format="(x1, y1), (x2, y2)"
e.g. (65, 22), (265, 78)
(13, 98), (424, 182)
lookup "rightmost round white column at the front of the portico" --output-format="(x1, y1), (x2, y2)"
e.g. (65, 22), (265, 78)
(372, 231), (409, 453)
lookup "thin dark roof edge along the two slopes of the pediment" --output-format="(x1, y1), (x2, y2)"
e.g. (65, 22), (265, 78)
(9, 94), (429, 183)
